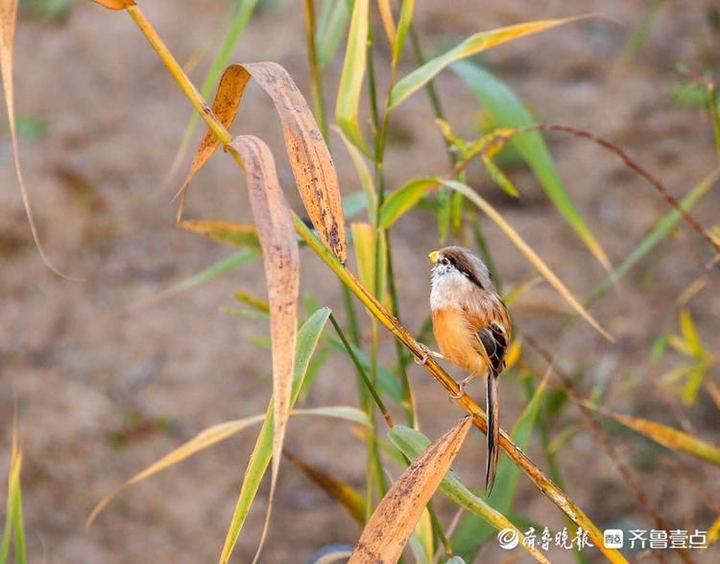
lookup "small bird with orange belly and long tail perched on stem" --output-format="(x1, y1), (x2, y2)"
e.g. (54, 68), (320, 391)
(420, 246), (512, 493)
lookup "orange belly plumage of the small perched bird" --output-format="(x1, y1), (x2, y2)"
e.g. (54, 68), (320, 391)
(432, 308), (487, 376)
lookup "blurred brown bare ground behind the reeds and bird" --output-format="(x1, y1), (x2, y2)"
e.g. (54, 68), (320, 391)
(0, 0), (720, 563)
